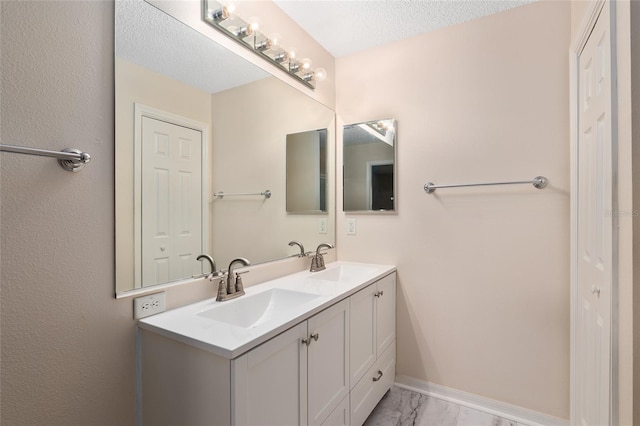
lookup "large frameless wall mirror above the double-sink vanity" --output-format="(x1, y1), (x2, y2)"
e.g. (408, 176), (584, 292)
(115, 0), (335, 296)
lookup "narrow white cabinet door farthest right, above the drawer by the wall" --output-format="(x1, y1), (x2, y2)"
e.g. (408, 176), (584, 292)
(376, 273), (396, 356)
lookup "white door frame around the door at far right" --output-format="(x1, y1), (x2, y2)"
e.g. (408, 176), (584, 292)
(569, 0), (618, 425)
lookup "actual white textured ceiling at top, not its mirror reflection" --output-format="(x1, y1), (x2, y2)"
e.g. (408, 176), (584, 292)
(274, 0), (534, 57)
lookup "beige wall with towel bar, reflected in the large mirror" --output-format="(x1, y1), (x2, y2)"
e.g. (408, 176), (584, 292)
(210, 78), (335, 268)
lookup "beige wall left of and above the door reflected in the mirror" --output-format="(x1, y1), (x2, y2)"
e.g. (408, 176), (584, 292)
(115, 58), (211, 291)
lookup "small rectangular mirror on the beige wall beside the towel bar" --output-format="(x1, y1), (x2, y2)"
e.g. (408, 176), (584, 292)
(342, 119), (397, 212)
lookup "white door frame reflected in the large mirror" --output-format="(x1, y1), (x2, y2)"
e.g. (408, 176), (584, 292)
(133, 103), (210, 289)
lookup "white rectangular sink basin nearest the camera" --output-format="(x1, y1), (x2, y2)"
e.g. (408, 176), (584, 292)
(197, 288), (320, 328)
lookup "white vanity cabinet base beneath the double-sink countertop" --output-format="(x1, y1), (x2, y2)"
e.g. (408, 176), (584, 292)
(137, 266), (395, 426)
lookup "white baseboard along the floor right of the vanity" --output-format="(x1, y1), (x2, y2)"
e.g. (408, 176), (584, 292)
(395, 375), (569, 426)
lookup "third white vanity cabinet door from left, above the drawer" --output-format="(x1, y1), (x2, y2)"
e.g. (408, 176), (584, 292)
(349, 284), (377, 388)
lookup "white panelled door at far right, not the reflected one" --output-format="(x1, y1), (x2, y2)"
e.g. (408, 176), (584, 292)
(574, 2), (614, 426)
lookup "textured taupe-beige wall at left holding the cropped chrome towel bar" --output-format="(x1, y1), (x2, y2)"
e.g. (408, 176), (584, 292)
(0, 1), (335, 426)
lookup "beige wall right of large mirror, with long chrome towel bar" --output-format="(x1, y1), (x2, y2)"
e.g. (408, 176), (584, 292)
(336, 2), (571, 419)
